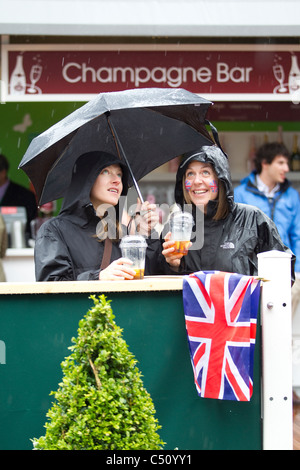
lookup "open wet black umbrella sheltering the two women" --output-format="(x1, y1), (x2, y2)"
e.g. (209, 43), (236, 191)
(19, 88), (214, 205)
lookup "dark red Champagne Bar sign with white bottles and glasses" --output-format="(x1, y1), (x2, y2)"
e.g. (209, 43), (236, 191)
(1, 44), (300, 104)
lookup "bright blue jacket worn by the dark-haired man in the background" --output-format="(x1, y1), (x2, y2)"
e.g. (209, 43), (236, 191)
(234, 172), (300, 272)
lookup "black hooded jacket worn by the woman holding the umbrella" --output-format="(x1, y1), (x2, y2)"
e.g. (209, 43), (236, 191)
(35, 152), (158, 281)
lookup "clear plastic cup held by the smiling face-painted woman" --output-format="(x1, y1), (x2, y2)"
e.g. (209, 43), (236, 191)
(170, 212), (194, 255)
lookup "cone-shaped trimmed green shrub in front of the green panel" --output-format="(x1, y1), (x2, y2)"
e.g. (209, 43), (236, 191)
(33, 295), (164, 450)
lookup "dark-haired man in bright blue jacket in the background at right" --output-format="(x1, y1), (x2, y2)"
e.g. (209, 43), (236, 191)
(234, 142), (300, 403)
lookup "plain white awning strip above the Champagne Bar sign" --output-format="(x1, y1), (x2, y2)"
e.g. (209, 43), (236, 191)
(0, 0), (300, 37)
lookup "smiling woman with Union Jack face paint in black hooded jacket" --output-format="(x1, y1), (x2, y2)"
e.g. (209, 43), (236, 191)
(162, 146), (295, 279)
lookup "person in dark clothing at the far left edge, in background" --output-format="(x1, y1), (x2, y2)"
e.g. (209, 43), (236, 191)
(0, 154), (37, 241)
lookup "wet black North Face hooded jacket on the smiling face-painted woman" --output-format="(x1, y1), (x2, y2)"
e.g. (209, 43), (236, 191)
(169, 146), (295, 279)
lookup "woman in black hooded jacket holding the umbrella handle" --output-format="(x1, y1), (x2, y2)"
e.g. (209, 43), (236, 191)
(35, 152), (158, 281)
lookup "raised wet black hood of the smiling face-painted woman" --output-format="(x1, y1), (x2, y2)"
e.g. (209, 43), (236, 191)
(175, 145), (234, 210)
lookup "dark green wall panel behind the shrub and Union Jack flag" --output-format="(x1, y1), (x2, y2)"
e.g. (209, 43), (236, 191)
(0, 291), (262, 450)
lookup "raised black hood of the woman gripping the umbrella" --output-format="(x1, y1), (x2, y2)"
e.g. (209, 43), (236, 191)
(61, 152), (128, 213)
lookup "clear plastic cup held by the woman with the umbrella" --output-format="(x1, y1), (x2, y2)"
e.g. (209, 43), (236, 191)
(120, 235), (147, 279)
